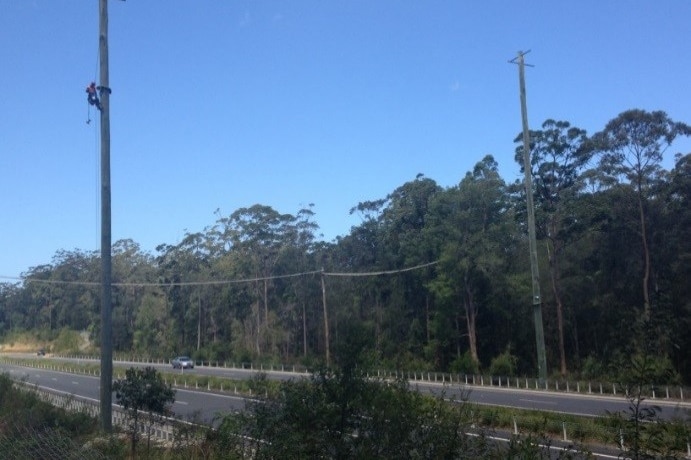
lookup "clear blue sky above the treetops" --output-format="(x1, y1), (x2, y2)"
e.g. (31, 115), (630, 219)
(0, 0), (691, 281)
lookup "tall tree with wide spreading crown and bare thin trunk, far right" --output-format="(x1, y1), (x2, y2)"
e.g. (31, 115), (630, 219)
(593, 109), (691, 318)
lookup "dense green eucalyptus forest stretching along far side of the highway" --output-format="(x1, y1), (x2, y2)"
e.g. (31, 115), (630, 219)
(0, 110), (691, 382)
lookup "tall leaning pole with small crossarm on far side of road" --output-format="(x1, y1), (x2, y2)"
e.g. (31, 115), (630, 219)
(509, 51), (547, 380)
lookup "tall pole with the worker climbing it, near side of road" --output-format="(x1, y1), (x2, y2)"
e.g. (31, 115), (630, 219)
(99, 0), (113, 433)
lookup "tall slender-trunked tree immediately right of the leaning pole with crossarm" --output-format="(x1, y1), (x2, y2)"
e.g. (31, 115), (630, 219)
(515, 119), (591, 375)
